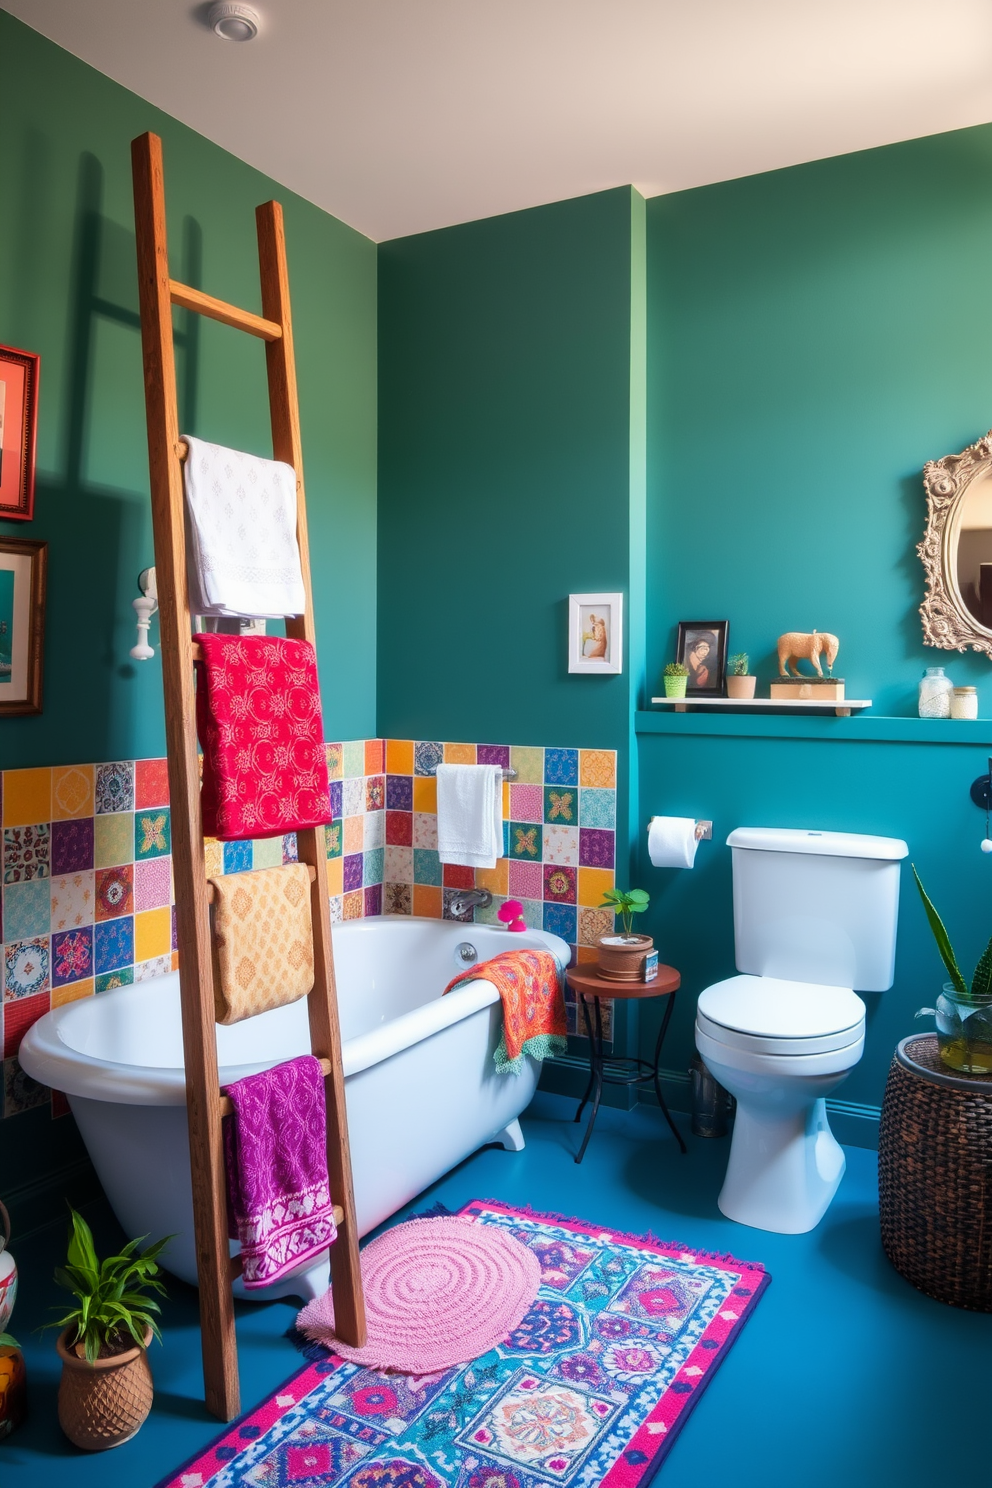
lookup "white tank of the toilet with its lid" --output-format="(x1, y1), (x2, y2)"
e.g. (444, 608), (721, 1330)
(727, 827), (909, 992)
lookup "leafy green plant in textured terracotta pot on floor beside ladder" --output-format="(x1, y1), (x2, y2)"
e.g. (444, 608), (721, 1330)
(49, 1205), (173, 1451)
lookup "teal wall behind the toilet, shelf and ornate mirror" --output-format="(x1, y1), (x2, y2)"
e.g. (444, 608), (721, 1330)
(640, 126), (992, 1124)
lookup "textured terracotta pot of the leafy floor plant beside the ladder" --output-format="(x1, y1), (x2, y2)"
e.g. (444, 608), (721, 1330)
(55, 1324), (152, 1452)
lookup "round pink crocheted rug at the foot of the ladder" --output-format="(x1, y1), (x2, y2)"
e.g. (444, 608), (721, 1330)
(296, 1216), (541, 1375)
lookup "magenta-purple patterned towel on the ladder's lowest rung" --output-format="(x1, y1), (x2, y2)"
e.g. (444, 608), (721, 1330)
(223, 1054), (338, 1287)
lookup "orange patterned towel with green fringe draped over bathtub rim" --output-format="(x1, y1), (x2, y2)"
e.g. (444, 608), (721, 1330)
(445, 951), (568, 1074)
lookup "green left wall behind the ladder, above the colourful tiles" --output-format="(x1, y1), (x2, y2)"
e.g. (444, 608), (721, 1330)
(0, 12), (376, 769)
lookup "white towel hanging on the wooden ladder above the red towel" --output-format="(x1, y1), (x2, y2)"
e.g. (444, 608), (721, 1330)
(183, 434), (306, 619)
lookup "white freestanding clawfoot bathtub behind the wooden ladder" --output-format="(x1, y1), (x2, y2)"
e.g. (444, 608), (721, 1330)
(19, 915), (568, 1301)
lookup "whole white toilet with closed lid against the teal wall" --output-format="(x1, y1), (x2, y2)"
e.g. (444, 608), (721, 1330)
(696, 827), (909, 1235)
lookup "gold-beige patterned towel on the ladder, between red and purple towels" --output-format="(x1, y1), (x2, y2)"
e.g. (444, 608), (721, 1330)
(210, 863), (314, 1024)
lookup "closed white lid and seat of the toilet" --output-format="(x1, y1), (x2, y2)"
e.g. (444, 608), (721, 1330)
(696, 976), (866, 1055)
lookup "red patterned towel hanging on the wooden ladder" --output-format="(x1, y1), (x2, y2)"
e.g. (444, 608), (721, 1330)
(193, 635), (330, 842)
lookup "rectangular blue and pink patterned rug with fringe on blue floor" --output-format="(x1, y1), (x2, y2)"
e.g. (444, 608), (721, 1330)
(159, 1201), (770, 1488)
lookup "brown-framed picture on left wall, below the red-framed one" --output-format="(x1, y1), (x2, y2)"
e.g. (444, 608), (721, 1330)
(0, 537), (48, 717)
